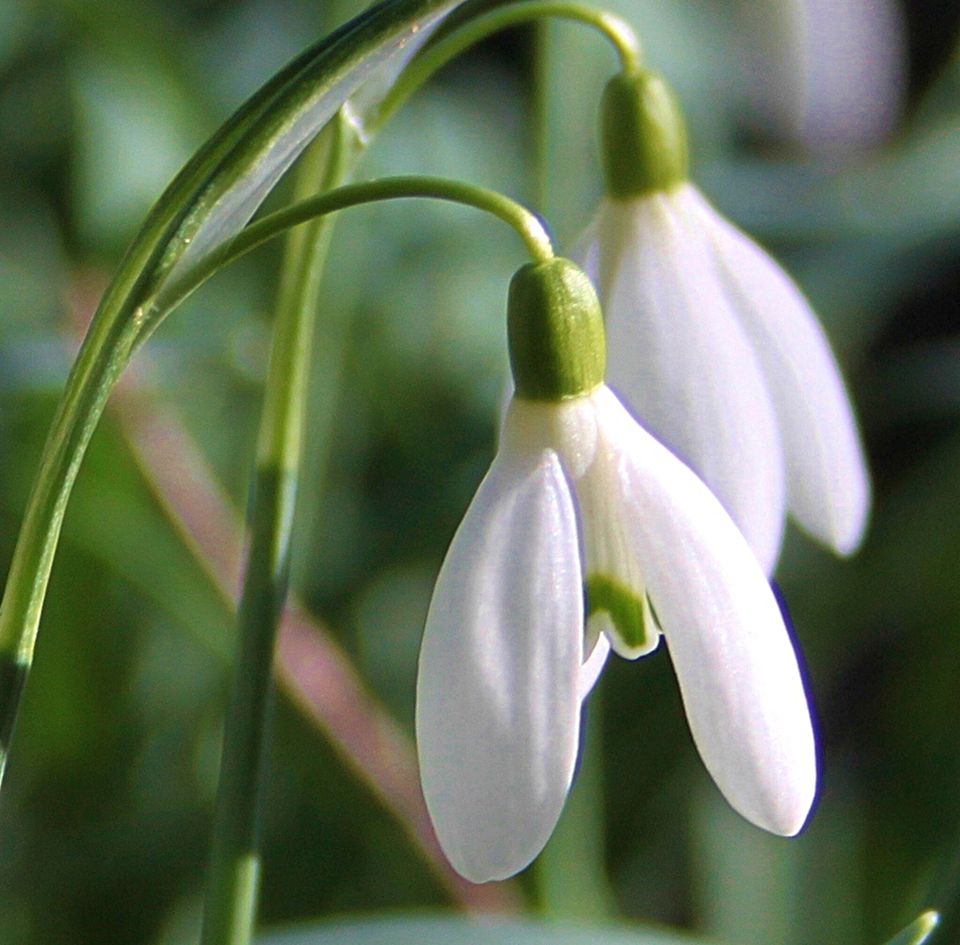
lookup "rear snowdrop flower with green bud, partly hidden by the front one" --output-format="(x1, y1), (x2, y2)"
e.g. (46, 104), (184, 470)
(580, 72), (870, 573)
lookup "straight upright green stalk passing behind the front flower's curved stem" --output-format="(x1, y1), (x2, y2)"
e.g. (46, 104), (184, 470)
(201, 117), (352, 945)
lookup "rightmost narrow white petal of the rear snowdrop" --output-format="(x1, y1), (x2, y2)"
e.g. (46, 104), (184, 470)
(686, 188), (870, 554)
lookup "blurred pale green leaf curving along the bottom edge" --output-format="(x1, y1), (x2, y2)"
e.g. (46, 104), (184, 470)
(258, 916), (700, 945)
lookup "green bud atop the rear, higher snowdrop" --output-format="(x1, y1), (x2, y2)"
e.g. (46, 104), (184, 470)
(600, 71), (688, 199)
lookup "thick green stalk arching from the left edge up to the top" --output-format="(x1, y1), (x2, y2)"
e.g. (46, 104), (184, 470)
(0, 0), (462, 780)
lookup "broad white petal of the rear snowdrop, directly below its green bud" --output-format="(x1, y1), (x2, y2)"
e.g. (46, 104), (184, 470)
(584, 185), (786, 573)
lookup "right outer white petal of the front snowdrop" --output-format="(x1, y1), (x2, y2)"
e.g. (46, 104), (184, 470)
(597, 391), (816, 836)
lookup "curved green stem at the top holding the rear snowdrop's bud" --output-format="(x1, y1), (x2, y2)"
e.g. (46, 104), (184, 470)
(378, 0), (642, 129)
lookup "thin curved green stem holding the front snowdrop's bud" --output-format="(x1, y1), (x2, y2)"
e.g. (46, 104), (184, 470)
(140, 177), (553, 322)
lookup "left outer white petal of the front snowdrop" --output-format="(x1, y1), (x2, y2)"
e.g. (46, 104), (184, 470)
(416, 418), (583, 882)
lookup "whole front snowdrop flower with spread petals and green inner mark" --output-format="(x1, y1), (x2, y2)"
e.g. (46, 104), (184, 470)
(416, 259), (816, 882)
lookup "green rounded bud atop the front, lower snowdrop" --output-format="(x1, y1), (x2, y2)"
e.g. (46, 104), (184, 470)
(507, 258), (607, 401)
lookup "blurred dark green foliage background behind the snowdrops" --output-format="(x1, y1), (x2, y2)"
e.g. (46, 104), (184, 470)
(0, 0), (960, 945)
